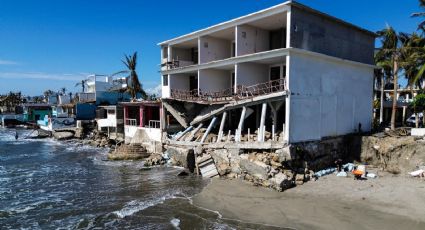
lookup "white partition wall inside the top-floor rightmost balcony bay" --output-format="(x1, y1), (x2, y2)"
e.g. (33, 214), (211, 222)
(236, 25), (270, 56)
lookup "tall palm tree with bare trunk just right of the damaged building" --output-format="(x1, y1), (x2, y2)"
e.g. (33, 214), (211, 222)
(375, 26), (402, 130)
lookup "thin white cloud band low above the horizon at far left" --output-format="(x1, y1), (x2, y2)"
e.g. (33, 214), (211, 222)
(0, 72), (87, 81)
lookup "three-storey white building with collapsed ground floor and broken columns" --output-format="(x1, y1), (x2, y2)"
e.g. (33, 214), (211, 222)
(159, 1), (375, 144)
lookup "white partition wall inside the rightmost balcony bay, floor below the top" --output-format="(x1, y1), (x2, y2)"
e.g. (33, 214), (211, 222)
(236, 63), (269, 86)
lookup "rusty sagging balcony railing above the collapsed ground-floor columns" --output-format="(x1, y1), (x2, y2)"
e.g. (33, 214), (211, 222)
(171, 79), (286, 102)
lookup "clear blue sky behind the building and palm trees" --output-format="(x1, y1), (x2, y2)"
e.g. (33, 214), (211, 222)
(0, 0), (420, 95)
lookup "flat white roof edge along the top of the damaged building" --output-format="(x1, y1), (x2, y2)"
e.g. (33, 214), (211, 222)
(158, 0), (376, 46)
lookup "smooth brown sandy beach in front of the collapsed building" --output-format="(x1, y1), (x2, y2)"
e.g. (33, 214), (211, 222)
(193, 174), (425, 230)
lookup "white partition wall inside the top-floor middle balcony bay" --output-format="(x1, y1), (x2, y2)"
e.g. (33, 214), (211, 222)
(199, 37), (231, 64)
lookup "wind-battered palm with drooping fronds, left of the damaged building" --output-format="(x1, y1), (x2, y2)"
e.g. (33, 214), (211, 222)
(113, 52), (147, 101)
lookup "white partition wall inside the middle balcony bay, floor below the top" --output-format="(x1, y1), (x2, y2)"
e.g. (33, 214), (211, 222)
(199, 69), (231, 92)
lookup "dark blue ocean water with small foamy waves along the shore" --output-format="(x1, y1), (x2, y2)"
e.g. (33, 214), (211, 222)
(0, 128), (284, 229)
